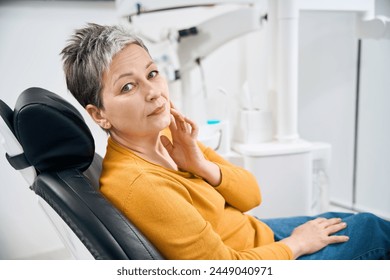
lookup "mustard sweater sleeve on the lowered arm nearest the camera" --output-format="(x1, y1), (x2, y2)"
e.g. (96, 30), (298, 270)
(116, 174), (292, 260)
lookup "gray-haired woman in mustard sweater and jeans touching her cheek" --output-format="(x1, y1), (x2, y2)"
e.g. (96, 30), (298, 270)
(62, 24), (390, 259)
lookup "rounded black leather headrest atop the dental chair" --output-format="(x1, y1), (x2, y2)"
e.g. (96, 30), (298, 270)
(13, 88), (95, 172)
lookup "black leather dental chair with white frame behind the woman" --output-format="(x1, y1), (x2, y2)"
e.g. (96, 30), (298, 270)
(0, 88), (163, 260)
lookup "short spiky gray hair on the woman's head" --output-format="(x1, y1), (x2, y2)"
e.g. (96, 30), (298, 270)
(61, 23), (149, 108)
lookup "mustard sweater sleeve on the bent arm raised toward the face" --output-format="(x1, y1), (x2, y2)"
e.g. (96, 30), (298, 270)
(199, 143), (261, 212)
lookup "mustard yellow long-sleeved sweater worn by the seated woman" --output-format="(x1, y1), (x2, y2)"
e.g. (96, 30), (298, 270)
(100, 138), (292, 260)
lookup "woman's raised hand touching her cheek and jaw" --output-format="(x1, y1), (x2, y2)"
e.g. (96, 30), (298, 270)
(161, 104), (221, 186)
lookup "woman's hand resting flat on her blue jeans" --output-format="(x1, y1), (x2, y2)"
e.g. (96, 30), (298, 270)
(280, 218), (349, 259)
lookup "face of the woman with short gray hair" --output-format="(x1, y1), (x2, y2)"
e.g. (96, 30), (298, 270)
(96, 44), (171, 139)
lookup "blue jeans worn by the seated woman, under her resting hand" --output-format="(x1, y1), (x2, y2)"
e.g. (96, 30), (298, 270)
(262, 212), (390, 260)
